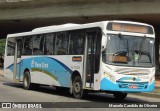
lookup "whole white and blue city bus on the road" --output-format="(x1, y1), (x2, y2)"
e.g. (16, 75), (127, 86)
(4, 21), (155, 99)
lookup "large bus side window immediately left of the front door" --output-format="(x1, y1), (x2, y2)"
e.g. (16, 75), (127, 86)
(69, 31), (85, 55)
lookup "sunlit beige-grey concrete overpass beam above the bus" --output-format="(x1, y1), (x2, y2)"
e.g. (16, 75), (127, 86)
(0, 0), (160, 22)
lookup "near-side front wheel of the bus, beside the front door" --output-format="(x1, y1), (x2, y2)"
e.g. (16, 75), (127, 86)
(72, 76), (85, 99)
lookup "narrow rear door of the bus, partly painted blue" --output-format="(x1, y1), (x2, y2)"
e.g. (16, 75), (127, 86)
(14, 39), (22, 82)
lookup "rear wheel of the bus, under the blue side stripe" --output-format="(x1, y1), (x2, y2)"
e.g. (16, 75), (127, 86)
(23, 71), (31, 90)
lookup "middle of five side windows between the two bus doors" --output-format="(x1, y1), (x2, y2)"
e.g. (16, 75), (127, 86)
(44, 34), (55, 55)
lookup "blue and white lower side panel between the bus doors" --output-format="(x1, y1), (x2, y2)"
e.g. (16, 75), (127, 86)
(21, 55), (83, 87)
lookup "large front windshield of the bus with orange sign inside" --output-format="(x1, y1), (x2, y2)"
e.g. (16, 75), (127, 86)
(102, 34), (154, 67)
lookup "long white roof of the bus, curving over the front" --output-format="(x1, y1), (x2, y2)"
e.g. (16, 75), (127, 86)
(7, 20), (153, 38)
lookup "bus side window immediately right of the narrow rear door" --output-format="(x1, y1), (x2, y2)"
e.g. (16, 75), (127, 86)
(22, 37), (32, 55)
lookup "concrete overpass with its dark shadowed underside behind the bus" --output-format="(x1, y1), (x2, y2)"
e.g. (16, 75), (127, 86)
(0, 0), (160, 74)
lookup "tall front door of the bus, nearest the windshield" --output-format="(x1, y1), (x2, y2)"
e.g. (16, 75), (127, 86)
(85, 29), (101, 88)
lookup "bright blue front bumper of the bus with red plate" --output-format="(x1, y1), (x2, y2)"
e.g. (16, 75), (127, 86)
(100, 78), (155, 93)
